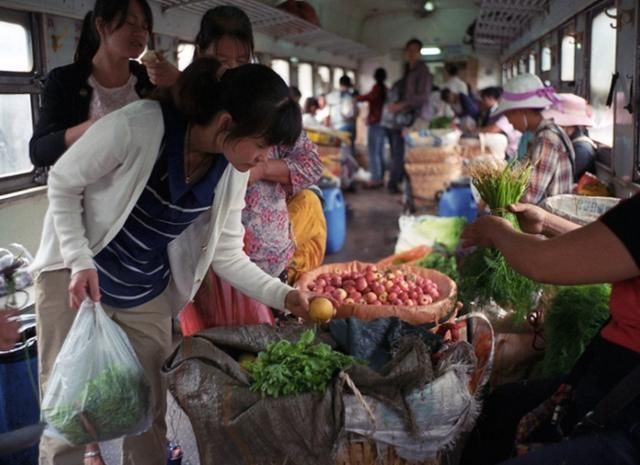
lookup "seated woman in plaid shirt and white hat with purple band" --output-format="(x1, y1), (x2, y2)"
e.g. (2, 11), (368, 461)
(494, 74), (575, 204)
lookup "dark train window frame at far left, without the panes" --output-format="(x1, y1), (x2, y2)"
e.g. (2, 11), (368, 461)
(0, 8), (44, 196)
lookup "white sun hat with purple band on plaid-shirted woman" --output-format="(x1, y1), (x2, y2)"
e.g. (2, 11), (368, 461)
(491, 73), (558, 117)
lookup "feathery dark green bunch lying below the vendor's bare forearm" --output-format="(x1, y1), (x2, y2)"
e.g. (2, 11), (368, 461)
(544, 284), (611, 376)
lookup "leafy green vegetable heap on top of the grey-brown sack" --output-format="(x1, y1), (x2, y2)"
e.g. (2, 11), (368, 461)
(247, 329), (356, 397)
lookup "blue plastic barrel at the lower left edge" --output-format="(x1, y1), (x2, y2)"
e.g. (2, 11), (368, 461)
(0, 325), (40, 465)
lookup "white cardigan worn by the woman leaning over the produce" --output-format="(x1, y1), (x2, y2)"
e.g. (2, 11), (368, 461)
(31, 100), (293, 313)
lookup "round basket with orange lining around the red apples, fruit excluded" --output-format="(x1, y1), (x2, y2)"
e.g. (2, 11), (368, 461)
(296, 261), (458, 325)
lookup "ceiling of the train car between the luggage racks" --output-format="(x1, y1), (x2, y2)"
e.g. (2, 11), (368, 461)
(157, 0), (549, 59)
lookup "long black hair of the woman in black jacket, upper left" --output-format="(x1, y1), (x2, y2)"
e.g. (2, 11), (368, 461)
(73, 0), (153, 63)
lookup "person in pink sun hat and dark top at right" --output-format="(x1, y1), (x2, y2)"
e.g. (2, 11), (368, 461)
(542, 94), (597, 181)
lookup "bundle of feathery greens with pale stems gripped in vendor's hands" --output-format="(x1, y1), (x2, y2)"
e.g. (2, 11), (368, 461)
(459, 162), (539, 317)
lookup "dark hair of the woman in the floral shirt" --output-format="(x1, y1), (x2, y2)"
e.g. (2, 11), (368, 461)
(193, 5), (254, 59)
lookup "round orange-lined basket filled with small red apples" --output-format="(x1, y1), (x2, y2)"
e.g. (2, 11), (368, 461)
(296, 261), (457, 325)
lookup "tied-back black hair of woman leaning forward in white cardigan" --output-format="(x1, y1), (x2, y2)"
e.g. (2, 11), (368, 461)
(157, 57), (302, 145)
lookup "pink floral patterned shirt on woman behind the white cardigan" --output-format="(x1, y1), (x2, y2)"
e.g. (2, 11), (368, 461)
(242, 131), (322, 276)
